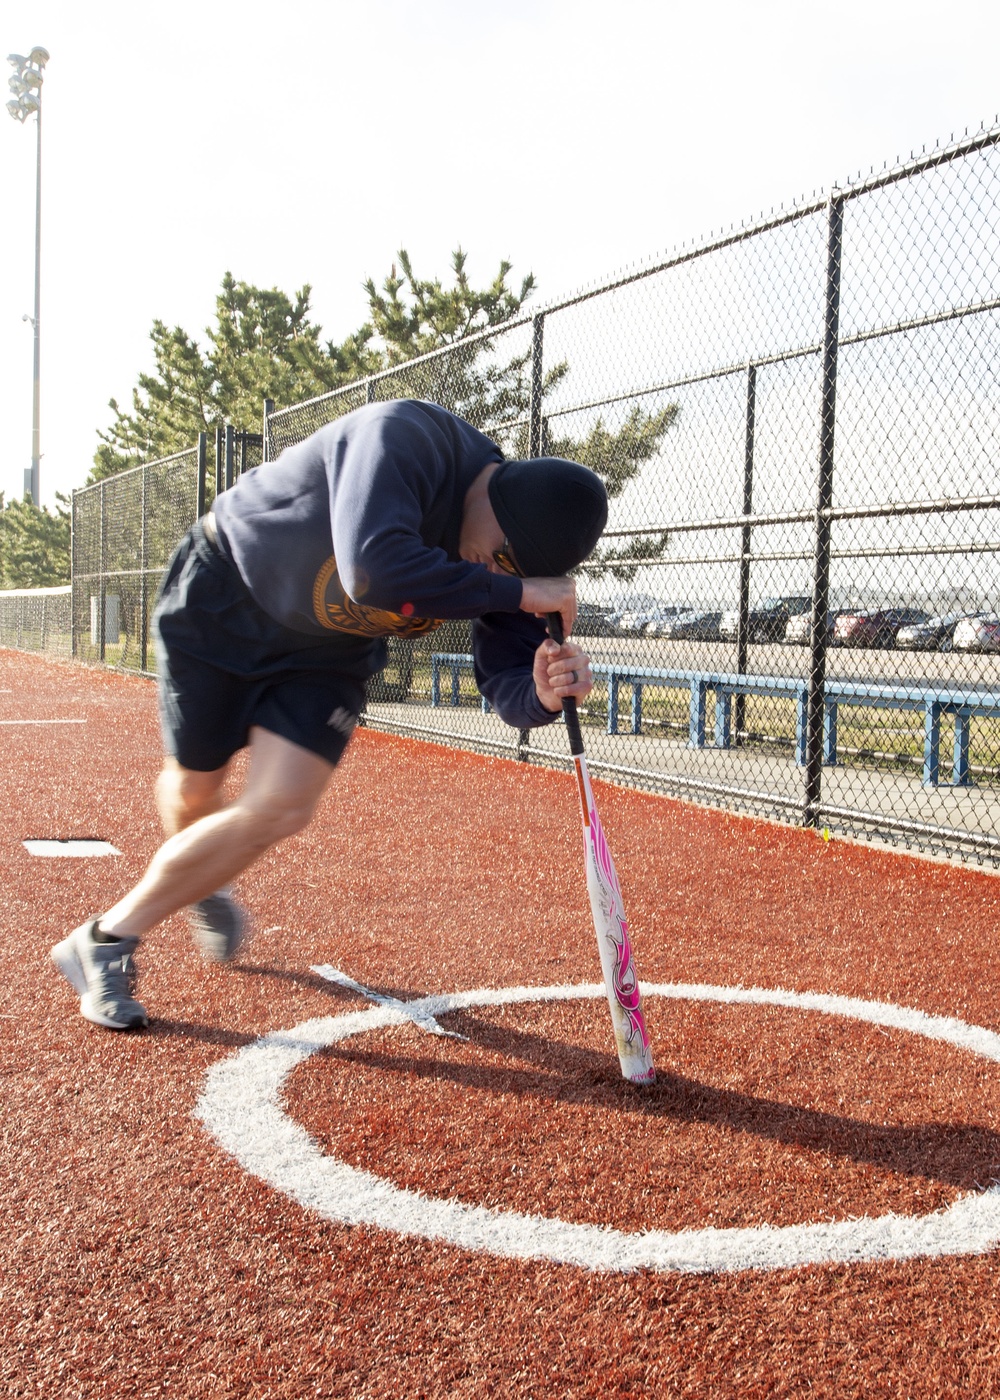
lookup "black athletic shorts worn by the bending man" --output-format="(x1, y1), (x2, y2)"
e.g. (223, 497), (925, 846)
(153, 524), (384, 773)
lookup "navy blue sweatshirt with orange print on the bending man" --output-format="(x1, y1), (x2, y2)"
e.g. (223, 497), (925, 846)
(214, 399), (557, 728)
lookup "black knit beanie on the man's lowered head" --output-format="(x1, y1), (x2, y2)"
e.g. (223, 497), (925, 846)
(489, 456), (608, 578)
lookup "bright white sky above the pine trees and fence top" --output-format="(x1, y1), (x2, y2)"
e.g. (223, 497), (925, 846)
(0, 0), (1000, 503)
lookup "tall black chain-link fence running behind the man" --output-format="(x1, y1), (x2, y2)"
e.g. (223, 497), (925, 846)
(7, 130), (1000, 864)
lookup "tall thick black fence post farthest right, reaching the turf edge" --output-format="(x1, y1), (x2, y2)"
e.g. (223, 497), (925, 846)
(803, 190), (845, 826)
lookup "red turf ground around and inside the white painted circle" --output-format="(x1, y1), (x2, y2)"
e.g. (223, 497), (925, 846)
(0, 651), (1000, 1400)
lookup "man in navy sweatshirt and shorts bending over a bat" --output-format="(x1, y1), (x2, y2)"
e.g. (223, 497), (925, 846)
(52, 400), (608, 1030)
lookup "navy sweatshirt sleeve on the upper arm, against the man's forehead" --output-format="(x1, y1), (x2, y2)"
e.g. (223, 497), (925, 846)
(328, 408), (521, 617)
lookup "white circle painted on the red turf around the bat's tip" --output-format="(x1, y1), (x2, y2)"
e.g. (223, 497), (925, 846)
(195, 983), (1000, 1273)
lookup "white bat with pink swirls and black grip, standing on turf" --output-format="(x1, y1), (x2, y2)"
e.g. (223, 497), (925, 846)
(549, 613), (655, 1084)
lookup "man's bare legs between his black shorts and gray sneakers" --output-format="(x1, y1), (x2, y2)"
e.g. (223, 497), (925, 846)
(101, 727), (333, 938)
